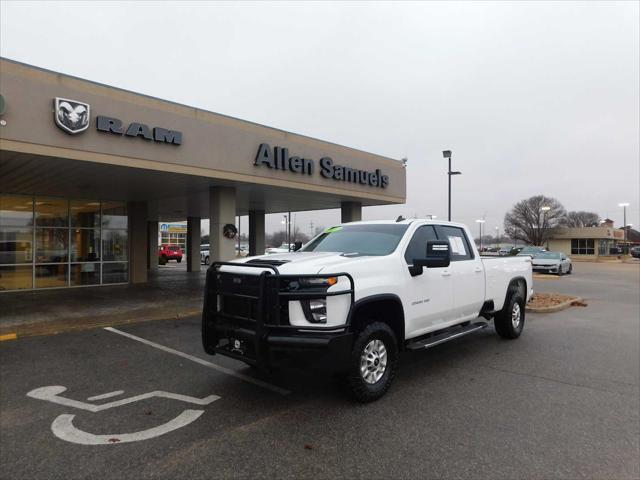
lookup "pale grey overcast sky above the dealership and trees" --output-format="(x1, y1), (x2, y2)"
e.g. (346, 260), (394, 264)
(0, 0), (640, 237)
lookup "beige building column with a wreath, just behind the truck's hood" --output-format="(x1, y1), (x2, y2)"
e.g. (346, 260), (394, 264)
(209, 187), (236, 262)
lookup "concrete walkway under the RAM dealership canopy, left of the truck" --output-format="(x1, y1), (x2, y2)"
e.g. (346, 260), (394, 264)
(0, 263), (206, 337)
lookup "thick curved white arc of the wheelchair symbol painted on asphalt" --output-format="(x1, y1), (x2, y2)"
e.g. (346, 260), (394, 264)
(51, 410), (204, 445)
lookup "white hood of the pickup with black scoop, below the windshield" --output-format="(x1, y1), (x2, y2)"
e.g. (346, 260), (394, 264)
(233, 252), (372, 274)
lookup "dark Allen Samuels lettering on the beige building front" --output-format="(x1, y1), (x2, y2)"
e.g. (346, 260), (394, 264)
(253, 143), (389, 188)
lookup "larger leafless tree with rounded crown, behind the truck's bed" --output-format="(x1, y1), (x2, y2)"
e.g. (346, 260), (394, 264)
(504, 195), (567, 245)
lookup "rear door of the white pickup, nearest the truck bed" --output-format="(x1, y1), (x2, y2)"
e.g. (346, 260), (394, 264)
(438, 225), (485, 319)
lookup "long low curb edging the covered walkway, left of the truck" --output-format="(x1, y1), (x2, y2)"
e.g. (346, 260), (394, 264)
(0, 309), (202, 340)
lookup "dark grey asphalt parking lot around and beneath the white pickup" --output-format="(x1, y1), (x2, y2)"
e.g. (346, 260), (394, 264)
(0, 263), (640, 479)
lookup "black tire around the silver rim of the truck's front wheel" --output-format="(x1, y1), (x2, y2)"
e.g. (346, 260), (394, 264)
(347, 322), (398, 403)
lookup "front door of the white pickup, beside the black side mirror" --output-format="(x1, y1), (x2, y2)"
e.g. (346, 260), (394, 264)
(404, 225), (453, 338)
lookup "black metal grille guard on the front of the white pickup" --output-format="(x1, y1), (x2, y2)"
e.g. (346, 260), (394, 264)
(202, 262), (355, 364)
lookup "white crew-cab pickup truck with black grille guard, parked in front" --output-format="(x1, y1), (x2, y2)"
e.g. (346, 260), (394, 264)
(202, 220), (533, 402)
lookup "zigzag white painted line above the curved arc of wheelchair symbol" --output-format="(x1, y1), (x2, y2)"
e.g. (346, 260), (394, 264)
(27, 385), (220, 413)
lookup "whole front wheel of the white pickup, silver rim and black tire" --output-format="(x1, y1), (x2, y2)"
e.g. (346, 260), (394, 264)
(347, 322), (398, 403)
